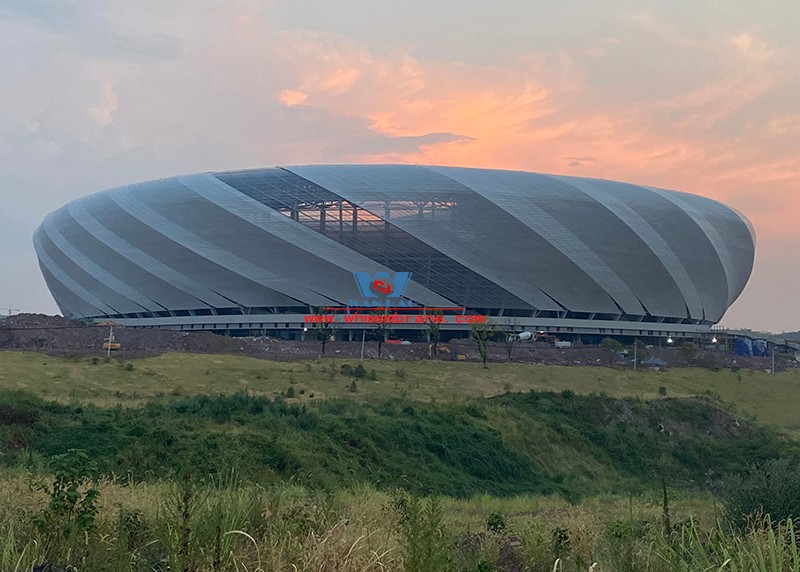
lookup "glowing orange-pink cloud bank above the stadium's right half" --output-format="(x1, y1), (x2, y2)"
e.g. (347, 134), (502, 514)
(272, 30), (800, 237)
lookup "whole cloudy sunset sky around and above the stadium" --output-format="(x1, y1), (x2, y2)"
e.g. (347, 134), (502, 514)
(0, 0), (800, 332)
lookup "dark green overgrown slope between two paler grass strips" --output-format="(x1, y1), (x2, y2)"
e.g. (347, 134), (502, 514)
(0, 391), (800, 498)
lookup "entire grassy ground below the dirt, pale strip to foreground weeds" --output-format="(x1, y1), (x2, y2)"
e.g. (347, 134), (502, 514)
(0, 352), (800, 572)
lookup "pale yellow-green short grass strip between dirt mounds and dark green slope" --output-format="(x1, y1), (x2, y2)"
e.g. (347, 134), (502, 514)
(0, 352), (800, 436)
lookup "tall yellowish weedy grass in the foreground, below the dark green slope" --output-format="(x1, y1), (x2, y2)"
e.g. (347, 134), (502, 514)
(0, 472), (800, 572)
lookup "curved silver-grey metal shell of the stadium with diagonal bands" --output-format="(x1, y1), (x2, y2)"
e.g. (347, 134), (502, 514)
(34, 165), (755, 324)
